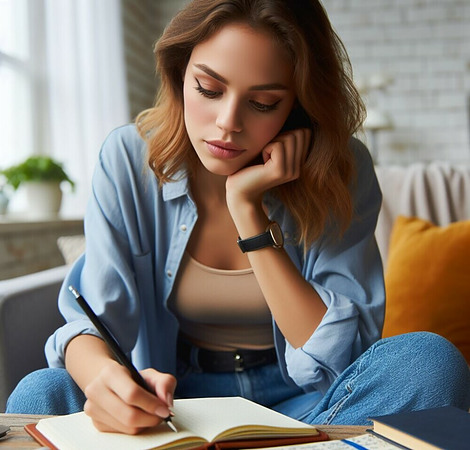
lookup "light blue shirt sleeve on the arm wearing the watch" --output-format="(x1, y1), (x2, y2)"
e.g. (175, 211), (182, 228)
(285, 140), (385, 392)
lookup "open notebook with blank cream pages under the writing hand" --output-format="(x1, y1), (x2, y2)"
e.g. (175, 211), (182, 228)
(25, 397), (328, 450)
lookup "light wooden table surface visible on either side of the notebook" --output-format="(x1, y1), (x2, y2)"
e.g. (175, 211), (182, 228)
(0, 414), (367, 450)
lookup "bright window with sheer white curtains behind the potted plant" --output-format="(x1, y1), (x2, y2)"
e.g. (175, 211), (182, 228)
(0, 0), (130, 216)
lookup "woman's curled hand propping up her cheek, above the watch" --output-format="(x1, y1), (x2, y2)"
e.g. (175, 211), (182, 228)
(226, 128), (312, 208)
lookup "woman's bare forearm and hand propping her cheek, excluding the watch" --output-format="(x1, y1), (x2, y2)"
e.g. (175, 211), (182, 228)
(226, 129), (326, 348)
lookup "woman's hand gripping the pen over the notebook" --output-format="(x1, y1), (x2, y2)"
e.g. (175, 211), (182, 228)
(84, 360), (176, 434)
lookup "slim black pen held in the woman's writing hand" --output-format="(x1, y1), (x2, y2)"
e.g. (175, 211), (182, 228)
(69, 286), (178, 433)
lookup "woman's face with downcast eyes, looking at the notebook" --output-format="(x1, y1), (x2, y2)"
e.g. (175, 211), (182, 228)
(183, 24), (295, 175)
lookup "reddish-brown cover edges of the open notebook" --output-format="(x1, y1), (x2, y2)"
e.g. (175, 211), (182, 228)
(24, 423), (330, 450)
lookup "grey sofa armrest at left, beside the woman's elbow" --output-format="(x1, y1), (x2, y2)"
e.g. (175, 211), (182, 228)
(0, 266), (69, 412)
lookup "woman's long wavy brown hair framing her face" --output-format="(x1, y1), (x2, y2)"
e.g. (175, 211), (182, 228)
(137, 0), (365, 246)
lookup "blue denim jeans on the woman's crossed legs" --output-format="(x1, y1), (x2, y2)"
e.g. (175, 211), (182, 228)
(7, 332), (470, 425)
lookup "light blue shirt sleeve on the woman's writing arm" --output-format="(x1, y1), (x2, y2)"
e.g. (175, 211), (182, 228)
(45, 128), (149, 367)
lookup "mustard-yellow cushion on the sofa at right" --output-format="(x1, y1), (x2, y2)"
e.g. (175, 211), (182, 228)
(383, 216), (470, 363)
